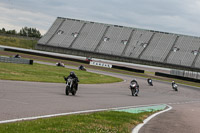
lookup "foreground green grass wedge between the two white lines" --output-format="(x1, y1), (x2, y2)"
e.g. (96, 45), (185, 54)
(0, 111), (153, 133)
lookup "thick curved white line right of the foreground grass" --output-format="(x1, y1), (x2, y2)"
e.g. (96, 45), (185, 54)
(132, 105), (172, 133)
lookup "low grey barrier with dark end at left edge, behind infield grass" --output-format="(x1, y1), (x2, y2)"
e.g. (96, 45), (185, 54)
(0, 56), (33, 65)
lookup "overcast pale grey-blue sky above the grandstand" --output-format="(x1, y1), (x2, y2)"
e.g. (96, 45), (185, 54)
(0, 0), (200, 36)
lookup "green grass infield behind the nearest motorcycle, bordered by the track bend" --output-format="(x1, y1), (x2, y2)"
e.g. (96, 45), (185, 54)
(0, 62), (122, 84)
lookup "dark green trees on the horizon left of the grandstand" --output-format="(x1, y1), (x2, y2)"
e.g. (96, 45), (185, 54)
(0, 27), (41, 38)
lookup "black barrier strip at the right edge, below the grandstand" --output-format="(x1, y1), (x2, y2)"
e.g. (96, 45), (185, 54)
(155, 72), (200, 83)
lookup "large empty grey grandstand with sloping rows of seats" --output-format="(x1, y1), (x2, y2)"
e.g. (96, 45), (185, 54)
(36, 17), (200, 70)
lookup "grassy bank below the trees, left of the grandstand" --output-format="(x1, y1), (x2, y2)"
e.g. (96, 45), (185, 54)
(0, 36), (37, 49)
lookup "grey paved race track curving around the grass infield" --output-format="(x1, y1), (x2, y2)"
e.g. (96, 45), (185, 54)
(0, 72), (200, 132)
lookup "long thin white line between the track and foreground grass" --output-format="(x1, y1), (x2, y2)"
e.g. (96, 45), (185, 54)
(0, 104), (167, 124)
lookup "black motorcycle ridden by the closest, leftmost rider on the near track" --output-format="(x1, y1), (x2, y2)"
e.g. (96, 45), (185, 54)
(64, 77), (77, 95)
